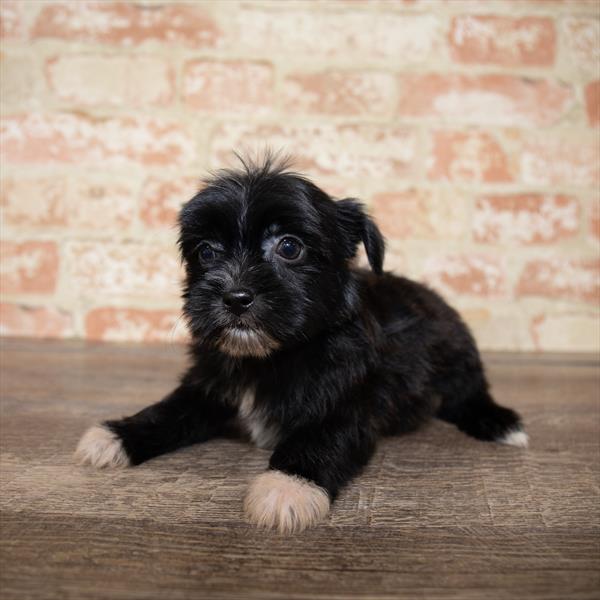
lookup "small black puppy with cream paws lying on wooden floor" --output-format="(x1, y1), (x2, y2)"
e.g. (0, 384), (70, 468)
(77, 159), (527, 532)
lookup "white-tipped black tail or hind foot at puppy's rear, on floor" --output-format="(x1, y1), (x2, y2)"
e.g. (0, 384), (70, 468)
(437, 389), (529, 448)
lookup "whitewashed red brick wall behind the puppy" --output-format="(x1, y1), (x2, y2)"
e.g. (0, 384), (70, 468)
(0, 0), (600, 351)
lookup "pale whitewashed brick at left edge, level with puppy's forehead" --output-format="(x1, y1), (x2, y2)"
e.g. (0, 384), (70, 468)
(0, 175), (137, 230)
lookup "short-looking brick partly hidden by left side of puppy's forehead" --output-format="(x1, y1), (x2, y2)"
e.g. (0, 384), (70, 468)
(140, 177), (200, 228)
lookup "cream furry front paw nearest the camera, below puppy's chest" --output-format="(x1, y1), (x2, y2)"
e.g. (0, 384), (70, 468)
(244, 471), (330, 533)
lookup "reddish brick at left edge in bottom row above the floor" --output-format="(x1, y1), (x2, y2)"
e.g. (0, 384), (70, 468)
(0, 303), (73, 338)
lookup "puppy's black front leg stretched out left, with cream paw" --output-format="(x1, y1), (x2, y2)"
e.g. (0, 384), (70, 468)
(75, 384), (233, 467)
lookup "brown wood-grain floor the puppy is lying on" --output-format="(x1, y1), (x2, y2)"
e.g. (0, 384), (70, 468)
(0, 340), (600, 600)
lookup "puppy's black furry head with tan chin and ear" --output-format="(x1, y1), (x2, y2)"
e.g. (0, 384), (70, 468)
(179, 158), (384, 357)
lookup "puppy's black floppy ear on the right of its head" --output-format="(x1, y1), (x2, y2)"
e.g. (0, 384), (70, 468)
(336, 198), (385, 275)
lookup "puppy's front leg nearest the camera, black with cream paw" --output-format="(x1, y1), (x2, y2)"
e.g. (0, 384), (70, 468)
(244, 423), (375, 534)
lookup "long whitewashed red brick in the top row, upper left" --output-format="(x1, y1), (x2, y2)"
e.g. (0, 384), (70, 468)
(31, 1), (219, 48)
